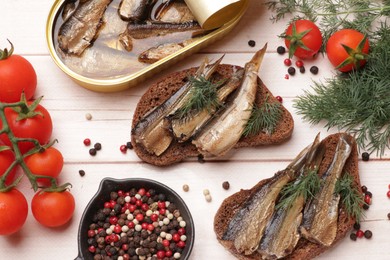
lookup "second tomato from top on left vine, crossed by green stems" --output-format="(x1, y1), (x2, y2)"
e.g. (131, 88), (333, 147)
(0, 102), (53, 153)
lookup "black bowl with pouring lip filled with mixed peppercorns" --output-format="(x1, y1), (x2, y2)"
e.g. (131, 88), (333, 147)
(76, 178), (195, 260)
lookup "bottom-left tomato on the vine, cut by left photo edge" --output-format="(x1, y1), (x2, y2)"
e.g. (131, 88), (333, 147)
(0, 189), (28, 235)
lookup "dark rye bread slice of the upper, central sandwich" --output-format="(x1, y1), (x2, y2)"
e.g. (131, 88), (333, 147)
(131, 64), (294, 166)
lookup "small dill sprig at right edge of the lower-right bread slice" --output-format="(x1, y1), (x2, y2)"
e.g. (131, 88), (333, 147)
(335, 173), (364, 222)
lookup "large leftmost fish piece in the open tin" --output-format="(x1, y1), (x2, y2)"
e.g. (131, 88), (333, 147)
(58, 0), (112, 55)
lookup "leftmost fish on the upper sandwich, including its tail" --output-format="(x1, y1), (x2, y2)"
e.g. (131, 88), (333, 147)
(132, 56), (223, 156)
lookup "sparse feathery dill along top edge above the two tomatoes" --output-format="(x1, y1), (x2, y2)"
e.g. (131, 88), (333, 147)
(265, 0), (390, 46)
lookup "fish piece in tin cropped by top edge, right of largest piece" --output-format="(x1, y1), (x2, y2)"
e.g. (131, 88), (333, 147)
(118, 0), (150, 21)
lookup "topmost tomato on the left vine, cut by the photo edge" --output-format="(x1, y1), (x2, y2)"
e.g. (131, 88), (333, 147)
(0, 43), (37, 103)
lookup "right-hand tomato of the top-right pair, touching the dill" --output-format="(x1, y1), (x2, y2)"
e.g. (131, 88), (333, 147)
(326, 29), (370, 72)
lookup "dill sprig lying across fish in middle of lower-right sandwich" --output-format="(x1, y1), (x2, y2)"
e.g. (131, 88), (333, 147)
(276, 167), (321, 209)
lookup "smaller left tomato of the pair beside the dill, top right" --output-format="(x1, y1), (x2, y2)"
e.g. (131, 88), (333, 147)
(285, 20), (322, 59)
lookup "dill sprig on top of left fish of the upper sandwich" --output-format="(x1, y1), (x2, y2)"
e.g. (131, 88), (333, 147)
(175, 77), (224, 119)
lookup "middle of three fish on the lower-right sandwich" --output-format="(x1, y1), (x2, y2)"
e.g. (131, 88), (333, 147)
(258, 135), (325, 259)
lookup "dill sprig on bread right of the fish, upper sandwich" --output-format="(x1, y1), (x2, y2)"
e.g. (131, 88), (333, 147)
(243, 95), (283, 136)
